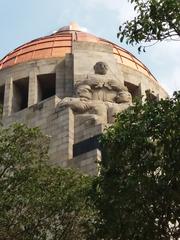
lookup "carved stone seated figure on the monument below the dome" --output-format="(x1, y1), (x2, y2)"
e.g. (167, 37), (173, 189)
(58, 62), (132, 123)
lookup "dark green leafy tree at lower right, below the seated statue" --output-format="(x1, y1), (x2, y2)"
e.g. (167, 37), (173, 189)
(93, 92), (180, 240)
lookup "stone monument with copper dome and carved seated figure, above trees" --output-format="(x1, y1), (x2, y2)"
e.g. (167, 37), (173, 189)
(0, 23), (167, 174)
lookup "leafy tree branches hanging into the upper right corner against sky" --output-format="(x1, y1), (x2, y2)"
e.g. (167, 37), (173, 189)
(118, 0), (180, 51)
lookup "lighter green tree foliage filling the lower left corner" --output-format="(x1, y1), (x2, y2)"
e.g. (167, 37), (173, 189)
(0, 125), (93, 240)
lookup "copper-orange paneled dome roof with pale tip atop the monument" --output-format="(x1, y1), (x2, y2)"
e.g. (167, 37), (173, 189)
(0, 23), (156, 80)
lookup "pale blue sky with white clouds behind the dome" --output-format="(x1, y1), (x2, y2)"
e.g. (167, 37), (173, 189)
(0, 0), (180, 95)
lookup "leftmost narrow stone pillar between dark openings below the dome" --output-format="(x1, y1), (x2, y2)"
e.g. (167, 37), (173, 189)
(3, 77), (13, 117)
